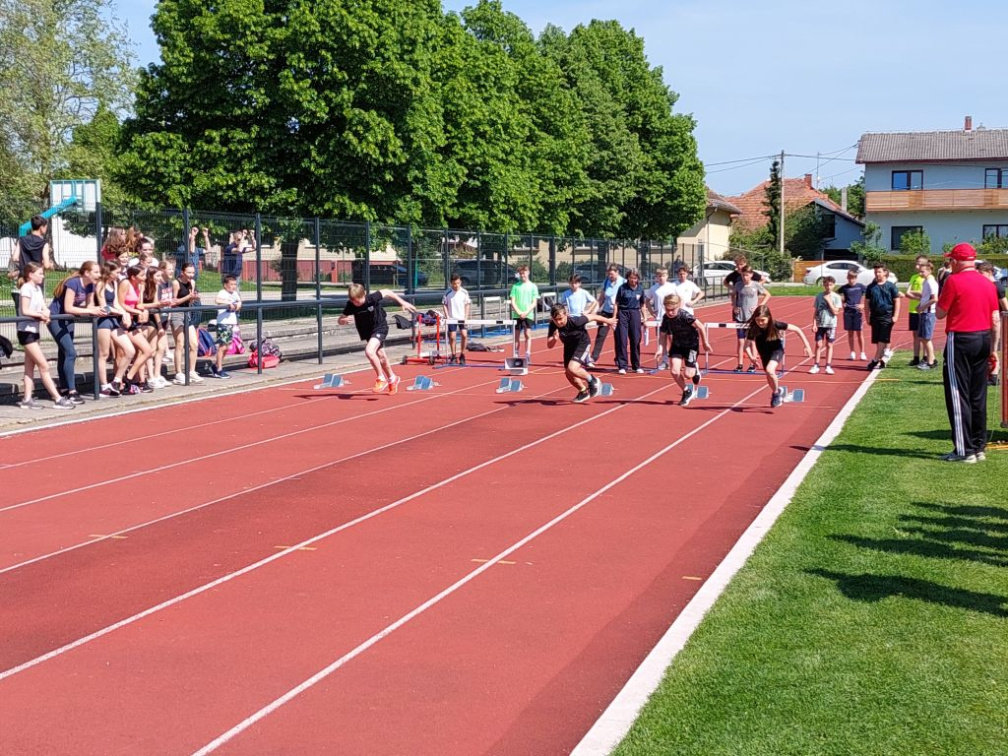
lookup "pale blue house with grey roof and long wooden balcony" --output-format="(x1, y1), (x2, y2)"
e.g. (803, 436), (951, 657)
(857, 116), (1008, 254)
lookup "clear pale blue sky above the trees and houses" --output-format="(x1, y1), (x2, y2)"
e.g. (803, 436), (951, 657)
(113, 0), (1008, 195)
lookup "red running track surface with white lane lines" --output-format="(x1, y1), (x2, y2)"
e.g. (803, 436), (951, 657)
(0, 298), (899, 756)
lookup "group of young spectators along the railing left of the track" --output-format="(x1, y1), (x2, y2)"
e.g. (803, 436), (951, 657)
(12, 216), (245, 409)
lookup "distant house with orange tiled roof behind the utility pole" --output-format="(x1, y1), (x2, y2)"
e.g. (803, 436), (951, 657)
(727, 173), (865, 259)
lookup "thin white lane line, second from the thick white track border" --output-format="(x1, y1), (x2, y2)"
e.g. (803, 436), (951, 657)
(0, 385), (685, 681)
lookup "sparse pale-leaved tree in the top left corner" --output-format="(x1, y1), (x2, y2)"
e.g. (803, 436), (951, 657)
(0, 0), (135, 211)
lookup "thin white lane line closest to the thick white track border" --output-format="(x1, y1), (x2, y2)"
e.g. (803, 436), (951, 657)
(193, 387), (763, 756)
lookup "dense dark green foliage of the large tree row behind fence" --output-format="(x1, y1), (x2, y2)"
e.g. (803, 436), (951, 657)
(117, 0), (706, 238)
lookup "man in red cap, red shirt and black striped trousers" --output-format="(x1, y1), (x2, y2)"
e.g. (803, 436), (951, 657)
(935, 243), (1001, 464)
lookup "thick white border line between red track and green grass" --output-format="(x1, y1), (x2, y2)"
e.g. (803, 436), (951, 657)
(571, 358), (879, 756)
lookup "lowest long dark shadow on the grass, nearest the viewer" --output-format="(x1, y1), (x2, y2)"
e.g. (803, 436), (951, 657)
(805, 570), (1008, 617)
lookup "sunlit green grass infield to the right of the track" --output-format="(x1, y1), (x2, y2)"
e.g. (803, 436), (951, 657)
(614, 355), (1008, 756)
